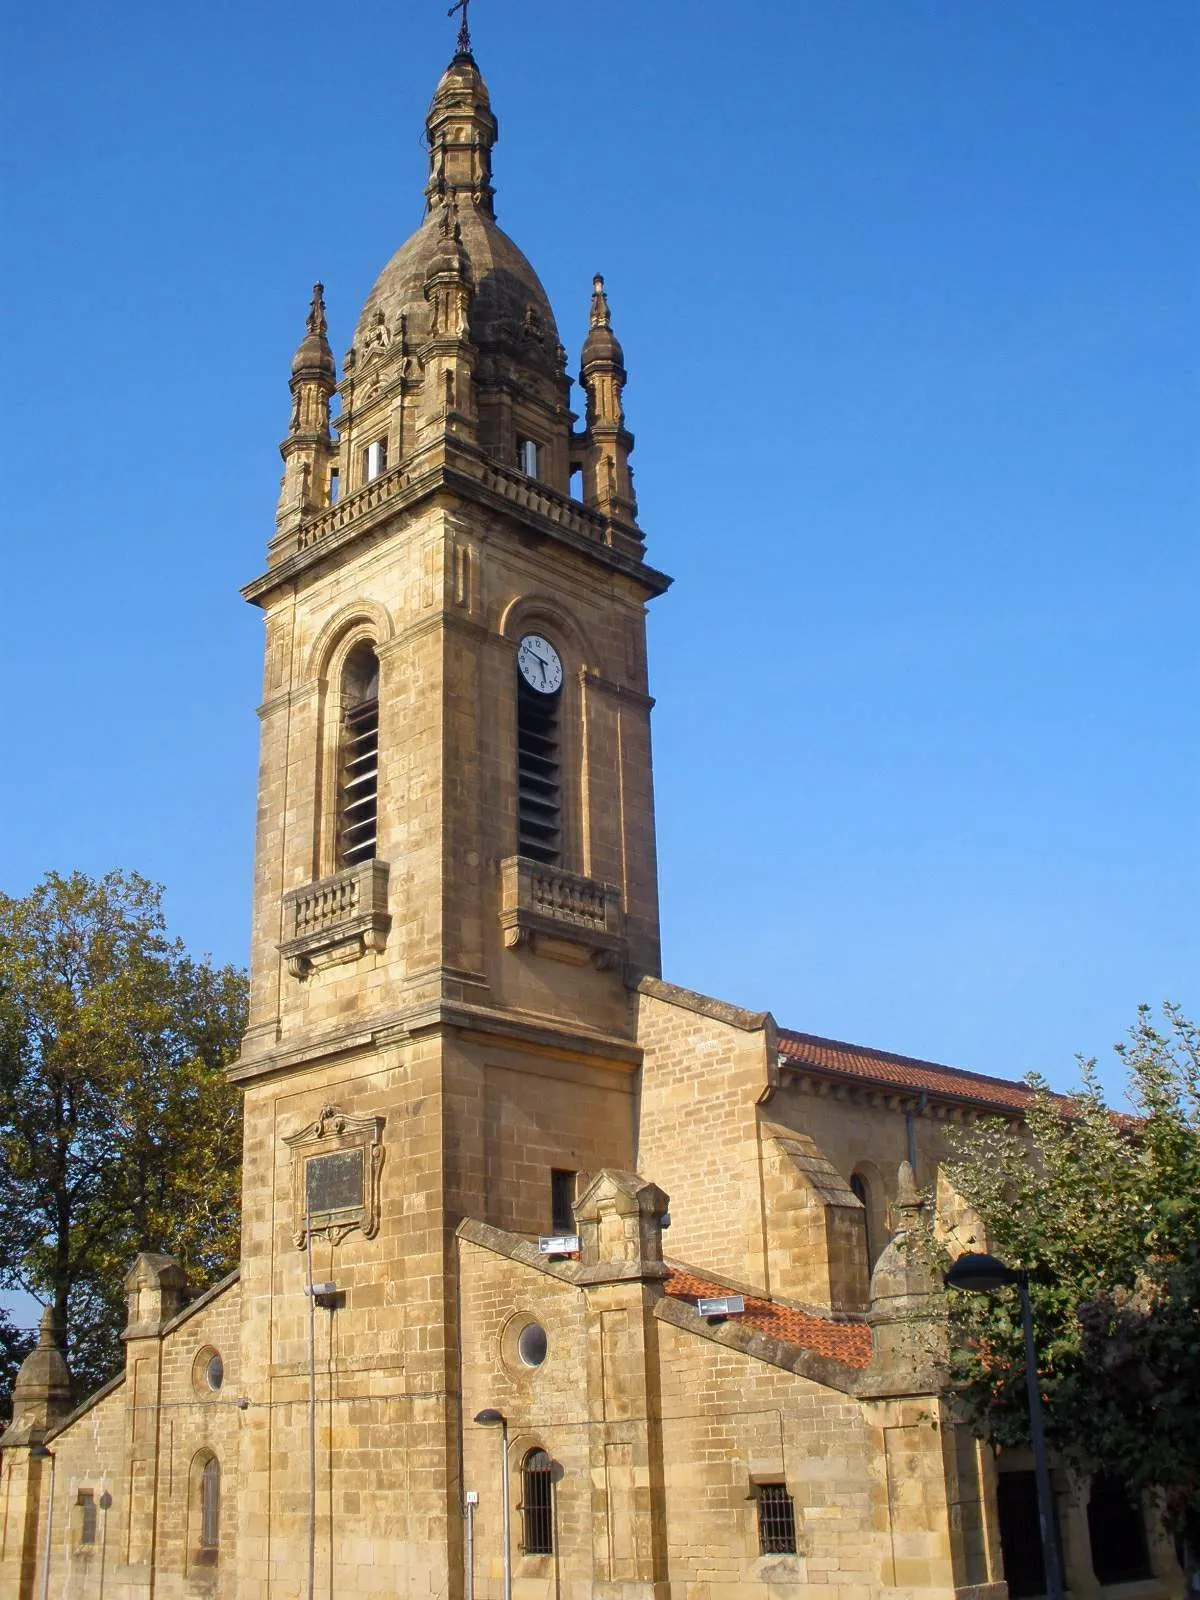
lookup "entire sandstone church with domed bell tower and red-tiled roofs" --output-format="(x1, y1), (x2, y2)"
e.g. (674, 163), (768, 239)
(0, 30), (1182, 1600)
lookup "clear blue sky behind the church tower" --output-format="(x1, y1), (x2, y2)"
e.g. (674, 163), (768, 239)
(0, 0), (1200, 1139)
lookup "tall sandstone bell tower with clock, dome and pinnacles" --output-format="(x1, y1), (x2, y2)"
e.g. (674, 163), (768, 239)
(234, 38), (669, 1595)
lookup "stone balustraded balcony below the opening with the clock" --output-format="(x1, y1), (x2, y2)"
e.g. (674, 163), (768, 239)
(501, 856), (626, 968)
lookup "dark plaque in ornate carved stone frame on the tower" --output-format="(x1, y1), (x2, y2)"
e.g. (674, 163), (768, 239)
(283, 1106), (384, 1250)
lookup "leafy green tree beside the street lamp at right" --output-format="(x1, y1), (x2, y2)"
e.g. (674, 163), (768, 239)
(947, 1006), (1200, 1570)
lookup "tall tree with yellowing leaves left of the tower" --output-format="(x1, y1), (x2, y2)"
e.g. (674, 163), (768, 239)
(0, 872), (246, 1394)
